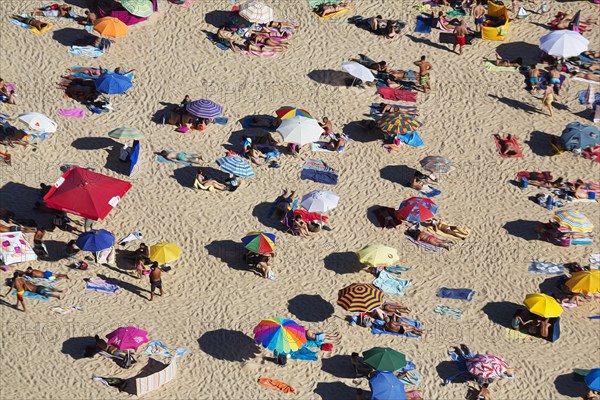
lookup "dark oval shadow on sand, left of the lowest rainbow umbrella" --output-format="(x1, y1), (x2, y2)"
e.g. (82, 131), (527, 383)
(198, 329), (260, 362)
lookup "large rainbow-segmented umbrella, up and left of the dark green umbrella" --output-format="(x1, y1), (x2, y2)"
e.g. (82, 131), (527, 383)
(254, 318), (306, 353)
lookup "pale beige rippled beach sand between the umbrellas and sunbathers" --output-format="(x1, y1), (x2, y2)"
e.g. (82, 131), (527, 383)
(0, 0), (600, 400)
